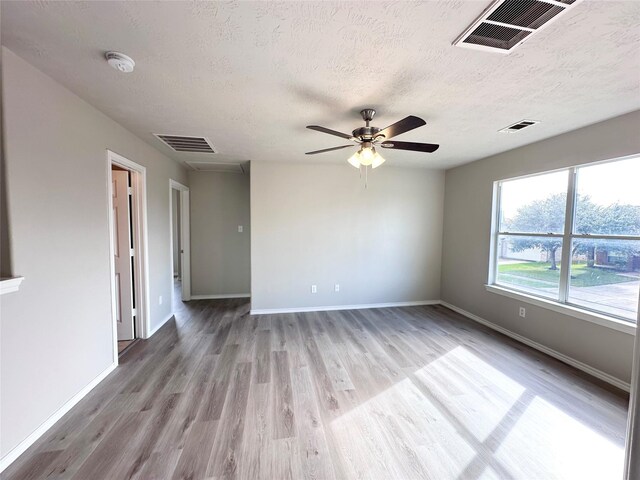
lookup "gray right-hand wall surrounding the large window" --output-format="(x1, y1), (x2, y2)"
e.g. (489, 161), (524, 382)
(442, 112), (640, 381)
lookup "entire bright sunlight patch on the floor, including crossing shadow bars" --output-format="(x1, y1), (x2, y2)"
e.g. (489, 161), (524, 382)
(331, 346), (624, 480)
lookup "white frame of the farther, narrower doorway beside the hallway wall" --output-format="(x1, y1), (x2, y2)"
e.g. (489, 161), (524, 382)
(169, 179), (191, 305)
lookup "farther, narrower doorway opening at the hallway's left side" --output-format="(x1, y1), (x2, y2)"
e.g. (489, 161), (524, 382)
(169, 180), (191, 304)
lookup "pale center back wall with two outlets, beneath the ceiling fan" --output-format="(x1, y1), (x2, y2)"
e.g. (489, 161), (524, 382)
(251, 162), (444, 309)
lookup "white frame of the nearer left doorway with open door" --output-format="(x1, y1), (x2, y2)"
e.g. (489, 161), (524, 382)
(107, 150), (151, 365)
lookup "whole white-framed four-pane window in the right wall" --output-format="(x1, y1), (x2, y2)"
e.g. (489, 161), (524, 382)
(490, 157), (640, 323)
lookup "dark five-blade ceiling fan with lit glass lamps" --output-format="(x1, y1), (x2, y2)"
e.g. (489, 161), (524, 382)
(307, 108), (440, 168)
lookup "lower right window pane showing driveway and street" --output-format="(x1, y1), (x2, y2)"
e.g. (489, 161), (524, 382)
(568, 239), (640, 322)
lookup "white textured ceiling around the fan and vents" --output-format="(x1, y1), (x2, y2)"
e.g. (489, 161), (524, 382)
(0, 0), (640, 168)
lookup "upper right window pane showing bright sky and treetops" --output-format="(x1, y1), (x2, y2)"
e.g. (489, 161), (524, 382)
(573, 158), (640, 235)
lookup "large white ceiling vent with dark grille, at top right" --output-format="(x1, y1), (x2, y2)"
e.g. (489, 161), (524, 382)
(453, 0), (581, 53)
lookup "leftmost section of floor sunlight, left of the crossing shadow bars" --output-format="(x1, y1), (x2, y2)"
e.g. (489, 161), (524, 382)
(331, 379), (475, 479)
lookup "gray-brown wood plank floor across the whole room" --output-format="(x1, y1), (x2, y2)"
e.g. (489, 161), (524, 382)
(2, 300), (627, 480)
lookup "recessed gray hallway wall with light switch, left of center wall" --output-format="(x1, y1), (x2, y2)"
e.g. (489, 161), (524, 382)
(189, 171), (251, 295)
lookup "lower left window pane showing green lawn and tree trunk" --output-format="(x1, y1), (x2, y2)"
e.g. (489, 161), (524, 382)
(496, 235), (562, 300)
